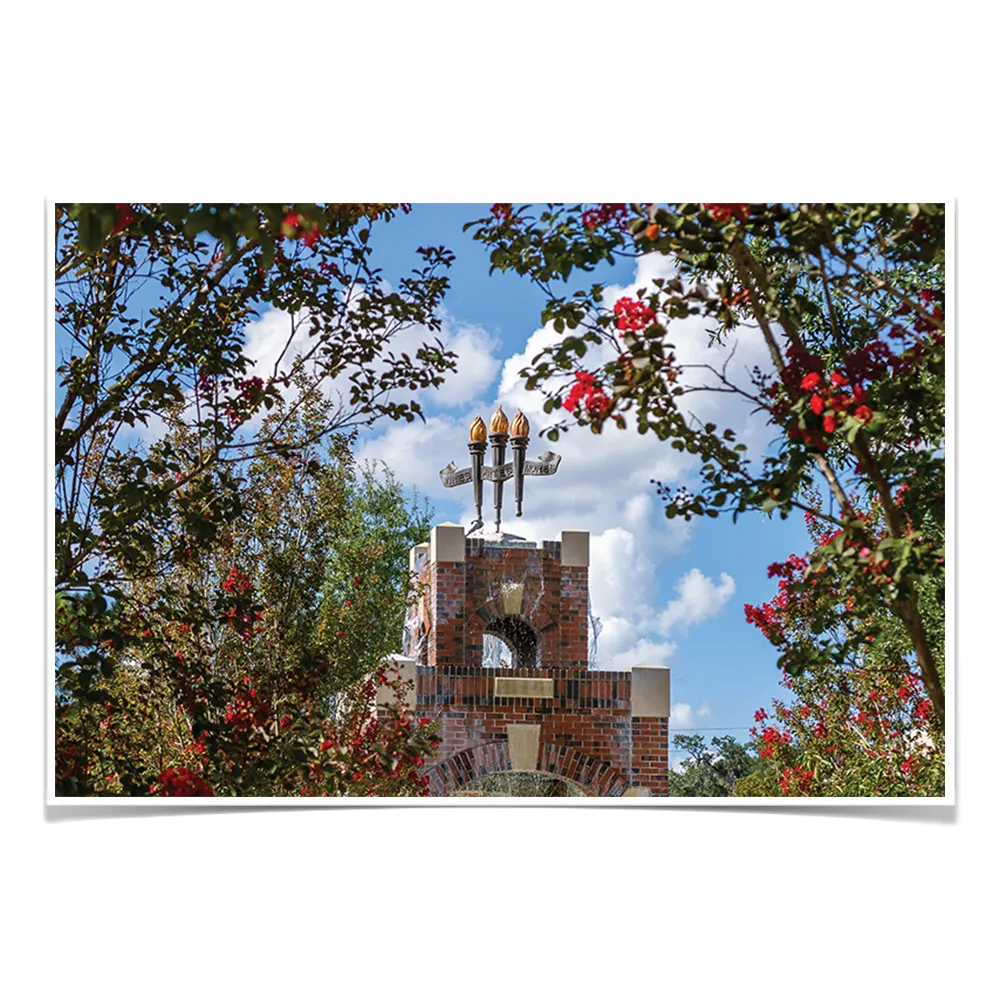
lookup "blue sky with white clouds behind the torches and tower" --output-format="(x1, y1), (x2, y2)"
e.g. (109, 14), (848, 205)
(238, 203), (809, 764)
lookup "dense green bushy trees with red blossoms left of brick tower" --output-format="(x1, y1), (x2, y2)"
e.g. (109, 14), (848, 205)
(55, 390), (437, 796)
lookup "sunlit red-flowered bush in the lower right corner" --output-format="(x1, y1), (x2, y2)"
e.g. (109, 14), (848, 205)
(736, 486), (945, 796)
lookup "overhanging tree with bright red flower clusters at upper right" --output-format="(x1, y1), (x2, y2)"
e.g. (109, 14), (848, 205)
(469, 203), (945, 730)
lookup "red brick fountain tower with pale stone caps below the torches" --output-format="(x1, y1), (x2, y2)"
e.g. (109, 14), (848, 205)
(397, 524), (670, 796)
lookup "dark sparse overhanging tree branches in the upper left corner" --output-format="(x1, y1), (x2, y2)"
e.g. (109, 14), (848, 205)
(53, 204), (455, 696)
